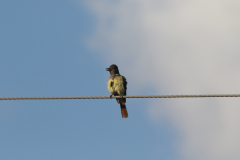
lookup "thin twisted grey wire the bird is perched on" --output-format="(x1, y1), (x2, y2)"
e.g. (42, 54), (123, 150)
(0, 94), (240, 100)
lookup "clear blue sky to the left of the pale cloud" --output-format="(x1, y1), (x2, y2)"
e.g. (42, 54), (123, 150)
(0, 0), (175, 160)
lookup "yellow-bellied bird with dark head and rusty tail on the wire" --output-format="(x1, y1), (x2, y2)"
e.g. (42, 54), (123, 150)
(106, 64), (128, 118)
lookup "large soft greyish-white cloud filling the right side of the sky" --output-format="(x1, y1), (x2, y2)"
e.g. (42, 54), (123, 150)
(83, 0), (240, 160)
